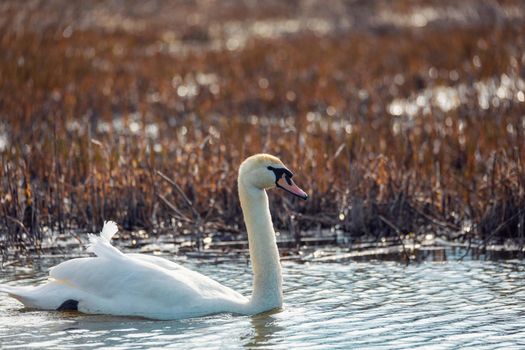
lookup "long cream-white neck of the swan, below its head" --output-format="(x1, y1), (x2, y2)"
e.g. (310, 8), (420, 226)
(239, 178), (283, 312)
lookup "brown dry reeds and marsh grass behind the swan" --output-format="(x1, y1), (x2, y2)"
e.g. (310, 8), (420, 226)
(0, 0), (525, 256)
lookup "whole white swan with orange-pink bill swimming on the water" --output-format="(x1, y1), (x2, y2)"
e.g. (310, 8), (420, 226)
(0, 154), (308, 320)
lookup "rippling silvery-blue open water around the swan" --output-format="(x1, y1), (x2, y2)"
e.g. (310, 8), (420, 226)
(0, 259), (525, 349)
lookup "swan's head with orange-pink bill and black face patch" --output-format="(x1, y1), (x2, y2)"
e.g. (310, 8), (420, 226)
(239, 154), (308, 199)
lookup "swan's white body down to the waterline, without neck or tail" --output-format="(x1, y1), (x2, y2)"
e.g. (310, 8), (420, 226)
(46, 254), (248, 318)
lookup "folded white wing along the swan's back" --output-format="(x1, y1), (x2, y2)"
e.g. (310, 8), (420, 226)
(49, 254), (243, 300)
